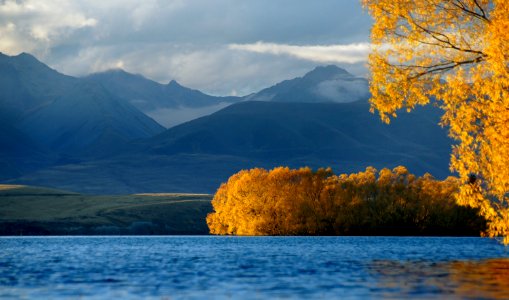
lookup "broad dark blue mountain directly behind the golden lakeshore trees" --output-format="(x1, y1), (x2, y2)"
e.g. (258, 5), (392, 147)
(7, 101), (451, 194)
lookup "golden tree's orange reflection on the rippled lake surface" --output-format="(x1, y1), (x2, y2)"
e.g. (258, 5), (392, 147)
(368, 258), (509, 299)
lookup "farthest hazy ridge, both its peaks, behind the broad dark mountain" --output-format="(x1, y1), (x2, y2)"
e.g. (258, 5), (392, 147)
(87, 65), (370, 128)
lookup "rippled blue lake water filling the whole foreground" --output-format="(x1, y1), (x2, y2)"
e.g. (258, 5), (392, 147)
(0, 236), (509, 299)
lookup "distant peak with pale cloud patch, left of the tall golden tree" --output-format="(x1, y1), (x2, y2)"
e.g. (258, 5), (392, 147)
(246, 65), (370, 103)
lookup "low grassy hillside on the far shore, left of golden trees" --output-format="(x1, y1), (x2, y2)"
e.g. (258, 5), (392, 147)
(0, 185), (212, 235)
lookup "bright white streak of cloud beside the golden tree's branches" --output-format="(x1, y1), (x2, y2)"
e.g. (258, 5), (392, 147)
(229, 42), (370, 64)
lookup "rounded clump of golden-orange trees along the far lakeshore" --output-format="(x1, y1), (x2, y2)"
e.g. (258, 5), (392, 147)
(207, 167), (484, 235)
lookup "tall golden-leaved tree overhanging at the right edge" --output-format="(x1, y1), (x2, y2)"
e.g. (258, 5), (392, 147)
(362, 0), (509, 244)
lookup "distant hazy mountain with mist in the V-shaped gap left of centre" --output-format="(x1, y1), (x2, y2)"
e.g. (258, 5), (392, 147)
(87, 70), (241, 127)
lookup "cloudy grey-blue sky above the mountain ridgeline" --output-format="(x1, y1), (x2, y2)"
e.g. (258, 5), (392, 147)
(0, 0), (371, 95)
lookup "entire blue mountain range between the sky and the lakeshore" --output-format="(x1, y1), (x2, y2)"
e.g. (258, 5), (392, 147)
(0, 53), (451, 194)
